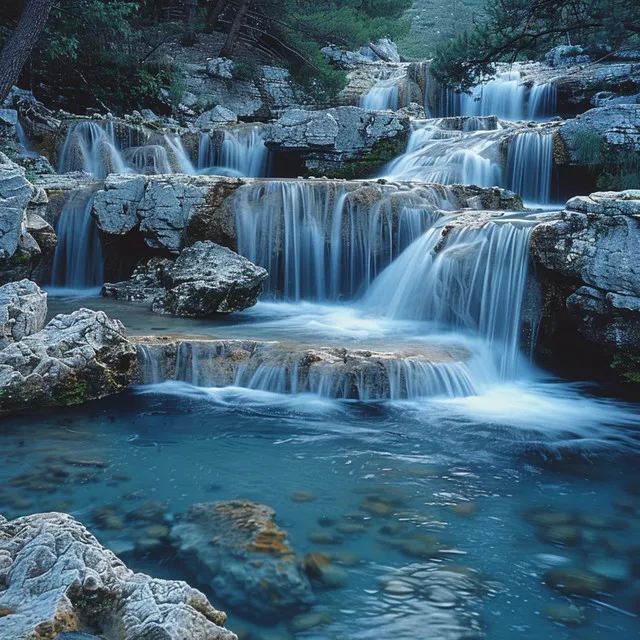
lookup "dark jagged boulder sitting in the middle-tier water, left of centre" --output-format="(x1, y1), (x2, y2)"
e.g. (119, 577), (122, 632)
(102, 242), (268, 317)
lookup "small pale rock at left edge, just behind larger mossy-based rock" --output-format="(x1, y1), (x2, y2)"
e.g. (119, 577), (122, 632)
(0, 280), (47, 349)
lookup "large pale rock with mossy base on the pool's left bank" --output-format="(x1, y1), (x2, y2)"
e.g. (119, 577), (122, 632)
(0, 309), (136, 411)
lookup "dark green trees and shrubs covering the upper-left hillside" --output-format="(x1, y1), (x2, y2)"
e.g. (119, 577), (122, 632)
(0, 0), (411, 112)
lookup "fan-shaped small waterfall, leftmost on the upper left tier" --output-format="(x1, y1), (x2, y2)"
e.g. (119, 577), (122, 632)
(58, 121), (131, 178)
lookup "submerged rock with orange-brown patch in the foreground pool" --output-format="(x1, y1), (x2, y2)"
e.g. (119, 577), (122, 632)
(171, 500), (314, 620)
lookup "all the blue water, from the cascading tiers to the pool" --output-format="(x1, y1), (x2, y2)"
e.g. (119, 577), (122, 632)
(10, 60), (640, 640)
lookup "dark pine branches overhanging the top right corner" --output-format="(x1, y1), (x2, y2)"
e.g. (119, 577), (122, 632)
(431, 0), (640, 90)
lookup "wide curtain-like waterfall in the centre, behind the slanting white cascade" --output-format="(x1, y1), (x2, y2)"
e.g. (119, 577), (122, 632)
(232, 181), (452, 300)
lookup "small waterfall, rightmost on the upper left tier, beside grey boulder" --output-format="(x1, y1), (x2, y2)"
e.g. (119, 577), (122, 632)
(198, 126), (269, 178)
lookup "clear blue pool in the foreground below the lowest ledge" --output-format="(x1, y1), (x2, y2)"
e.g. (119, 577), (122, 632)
(0, 378), (640, 640)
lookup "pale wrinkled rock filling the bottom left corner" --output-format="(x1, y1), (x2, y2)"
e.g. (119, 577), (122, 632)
(0, 513), (236, 640)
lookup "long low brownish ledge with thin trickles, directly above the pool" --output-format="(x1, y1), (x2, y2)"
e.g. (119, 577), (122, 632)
(135, 337), (473, 400)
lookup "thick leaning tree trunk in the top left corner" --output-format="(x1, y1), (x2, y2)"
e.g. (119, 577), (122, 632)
(0, 0), (55, 103)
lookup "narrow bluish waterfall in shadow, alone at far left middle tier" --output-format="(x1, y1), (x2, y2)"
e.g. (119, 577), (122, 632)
(51, 189), (103, 289)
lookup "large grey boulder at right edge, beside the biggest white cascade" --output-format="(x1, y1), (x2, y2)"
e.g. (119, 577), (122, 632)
(531, 190), (640, 355)
